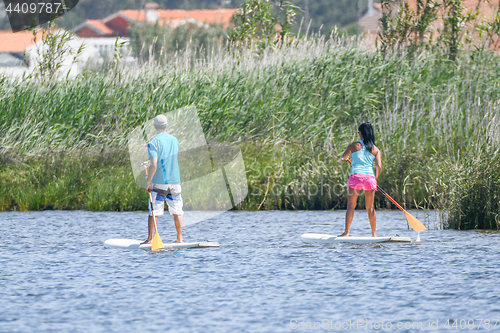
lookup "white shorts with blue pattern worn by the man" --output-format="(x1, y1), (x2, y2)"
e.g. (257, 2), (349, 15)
(148, 184), (184, 216)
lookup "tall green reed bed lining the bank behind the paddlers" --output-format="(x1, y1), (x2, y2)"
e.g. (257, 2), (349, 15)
(0, 35), (500, 229)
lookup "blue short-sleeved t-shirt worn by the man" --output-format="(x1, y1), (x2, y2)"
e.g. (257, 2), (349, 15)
(148, 133), (181, 184)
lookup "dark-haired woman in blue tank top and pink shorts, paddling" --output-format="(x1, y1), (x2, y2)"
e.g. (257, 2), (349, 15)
(338, 123), (382, 237)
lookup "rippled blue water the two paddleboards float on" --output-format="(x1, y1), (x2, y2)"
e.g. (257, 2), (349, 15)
(0, 211), (500, 332)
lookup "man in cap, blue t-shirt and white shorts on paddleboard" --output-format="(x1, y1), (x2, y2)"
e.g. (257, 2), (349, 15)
(143, 115), (184, 244)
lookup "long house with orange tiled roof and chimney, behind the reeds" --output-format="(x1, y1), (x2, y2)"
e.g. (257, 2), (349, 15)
(74, 3), (237, 38)
